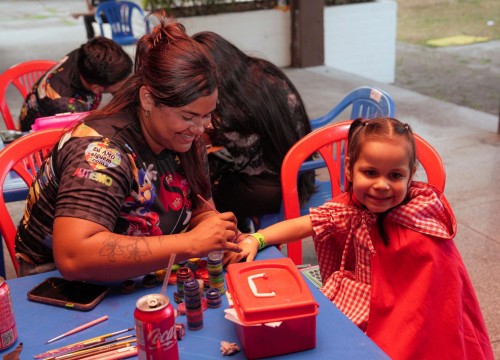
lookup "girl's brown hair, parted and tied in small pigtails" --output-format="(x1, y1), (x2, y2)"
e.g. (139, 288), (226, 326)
(346, 117), (417, 245)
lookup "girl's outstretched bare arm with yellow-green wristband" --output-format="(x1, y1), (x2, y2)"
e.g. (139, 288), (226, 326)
(224, 215), (313, 265)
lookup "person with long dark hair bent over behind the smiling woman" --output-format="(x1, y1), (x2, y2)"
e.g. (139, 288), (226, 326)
(193, 31), (314, 232)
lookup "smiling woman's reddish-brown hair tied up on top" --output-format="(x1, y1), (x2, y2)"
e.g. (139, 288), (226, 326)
(88, 9), (217, 203)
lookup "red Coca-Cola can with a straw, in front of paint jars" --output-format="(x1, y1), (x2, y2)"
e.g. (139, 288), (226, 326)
(134, 294), (179, 360)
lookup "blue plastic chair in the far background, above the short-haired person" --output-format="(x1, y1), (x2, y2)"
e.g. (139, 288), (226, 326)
(95, 1), (150, 46)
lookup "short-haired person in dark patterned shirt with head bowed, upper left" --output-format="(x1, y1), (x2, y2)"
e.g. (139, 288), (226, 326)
(19, 37), (133, 131)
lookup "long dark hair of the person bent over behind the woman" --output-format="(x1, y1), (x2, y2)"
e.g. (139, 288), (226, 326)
(193, 31), (314, 203)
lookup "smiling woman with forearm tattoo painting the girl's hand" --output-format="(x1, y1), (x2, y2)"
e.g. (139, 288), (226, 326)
(16, 11), (240, 281)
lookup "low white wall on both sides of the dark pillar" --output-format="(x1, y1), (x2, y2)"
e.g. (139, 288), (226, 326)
(130, 0), (397, 83)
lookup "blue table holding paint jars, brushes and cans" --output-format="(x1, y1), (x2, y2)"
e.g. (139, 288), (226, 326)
(0, 247), (389, 360)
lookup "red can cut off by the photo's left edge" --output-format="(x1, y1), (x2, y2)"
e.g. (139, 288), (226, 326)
(0, 276), (17, 350)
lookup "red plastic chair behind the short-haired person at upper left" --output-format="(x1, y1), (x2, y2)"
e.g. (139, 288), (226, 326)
(0, 60), (57, 130)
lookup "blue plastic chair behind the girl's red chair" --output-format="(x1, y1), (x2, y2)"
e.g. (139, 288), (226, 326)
(254, 86), (396, 230)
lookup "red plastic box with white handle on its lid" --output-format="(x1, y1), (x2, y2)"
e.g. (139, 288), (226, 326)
(225, 258), (318, 359)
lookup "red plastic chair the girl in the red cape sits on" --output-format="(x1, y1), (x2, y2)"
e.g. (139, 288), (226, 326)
(281, 120), (446, 265)
